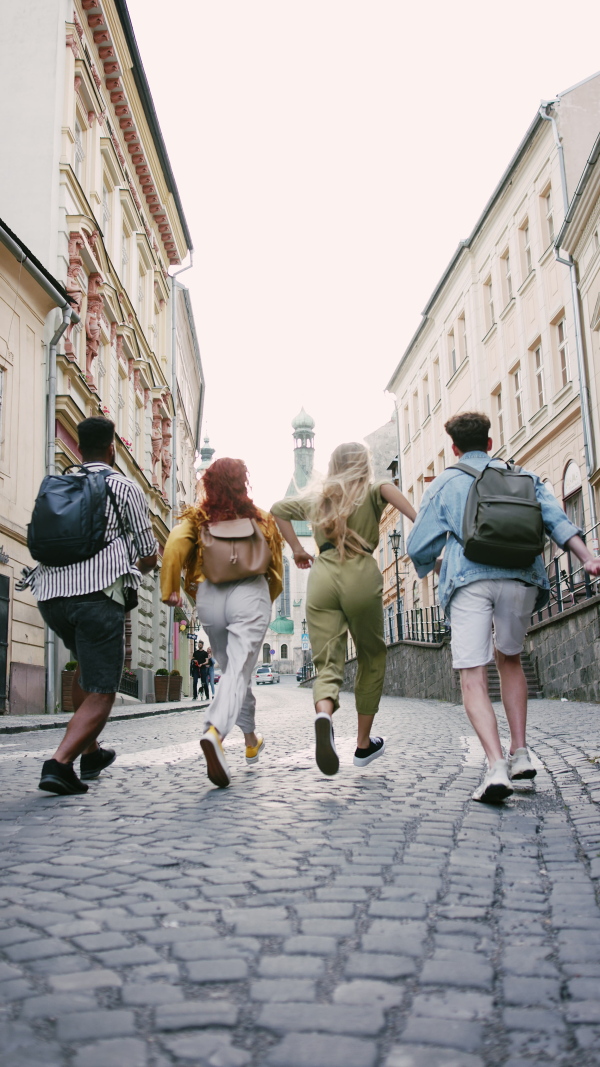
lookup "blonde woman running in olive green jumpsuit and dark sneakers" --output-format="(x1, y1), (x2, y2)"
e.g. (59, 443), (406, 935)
(271, 443), (416, 775)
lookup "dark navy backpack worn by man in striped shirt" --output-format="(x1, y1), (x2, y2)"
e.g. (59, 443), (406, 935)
(27, 463), (114, 567)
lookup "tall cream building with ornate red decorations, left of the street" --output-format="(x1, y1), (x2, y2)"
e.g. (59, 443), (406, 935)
(0, 6), (204, 717)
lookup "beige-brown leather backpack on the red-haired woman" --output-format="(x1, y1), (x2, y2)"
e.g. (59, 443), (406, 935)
(200, 519), (271, 586)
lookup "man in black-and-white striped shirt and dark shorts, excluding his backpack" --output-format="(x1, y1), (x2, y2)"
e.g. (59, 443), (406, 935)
(27, 417), (158, 795)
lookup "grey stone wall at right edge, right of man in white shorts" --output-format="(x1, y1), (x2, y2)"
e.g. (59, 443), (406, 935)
(525, 596), (600, 701)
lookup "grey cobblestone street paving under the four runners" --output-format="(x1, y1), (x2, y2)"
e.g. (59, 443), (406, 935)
(0, 684), (600, 1067)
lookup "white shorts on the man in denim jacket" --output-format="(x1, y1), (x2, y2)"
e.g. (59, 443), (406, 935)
(447, 578), (539, 670)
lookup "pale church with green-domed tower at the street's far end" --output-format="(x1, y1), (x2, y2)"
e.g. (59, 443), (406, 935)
(262, 408), (316, 674)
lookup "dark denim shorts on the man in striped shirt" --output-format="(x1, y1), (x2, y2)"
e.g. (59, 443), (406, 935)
(37, 591), (125, 692)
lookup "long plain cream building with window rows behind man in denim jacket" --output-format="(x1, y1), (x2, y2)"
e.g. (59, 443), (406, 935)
(388, 75), (600, 609)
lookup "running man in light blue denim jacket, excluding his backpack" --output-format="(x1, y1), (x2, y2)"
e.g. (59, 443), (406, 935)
(407, 412), (600, 803)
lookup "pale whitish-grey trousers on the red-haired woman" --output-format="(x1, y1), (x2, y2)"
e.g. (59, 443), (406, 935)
(196, 574), (271, 737)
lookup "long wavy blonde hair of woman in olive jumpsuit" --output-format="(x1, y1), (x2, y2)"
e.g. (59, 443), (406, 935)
(302, 441), (373, 559)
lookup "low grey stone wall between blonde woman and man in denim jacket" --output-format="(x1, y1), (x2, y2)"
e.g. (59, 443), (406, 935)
(342, 640), (462, 704)
